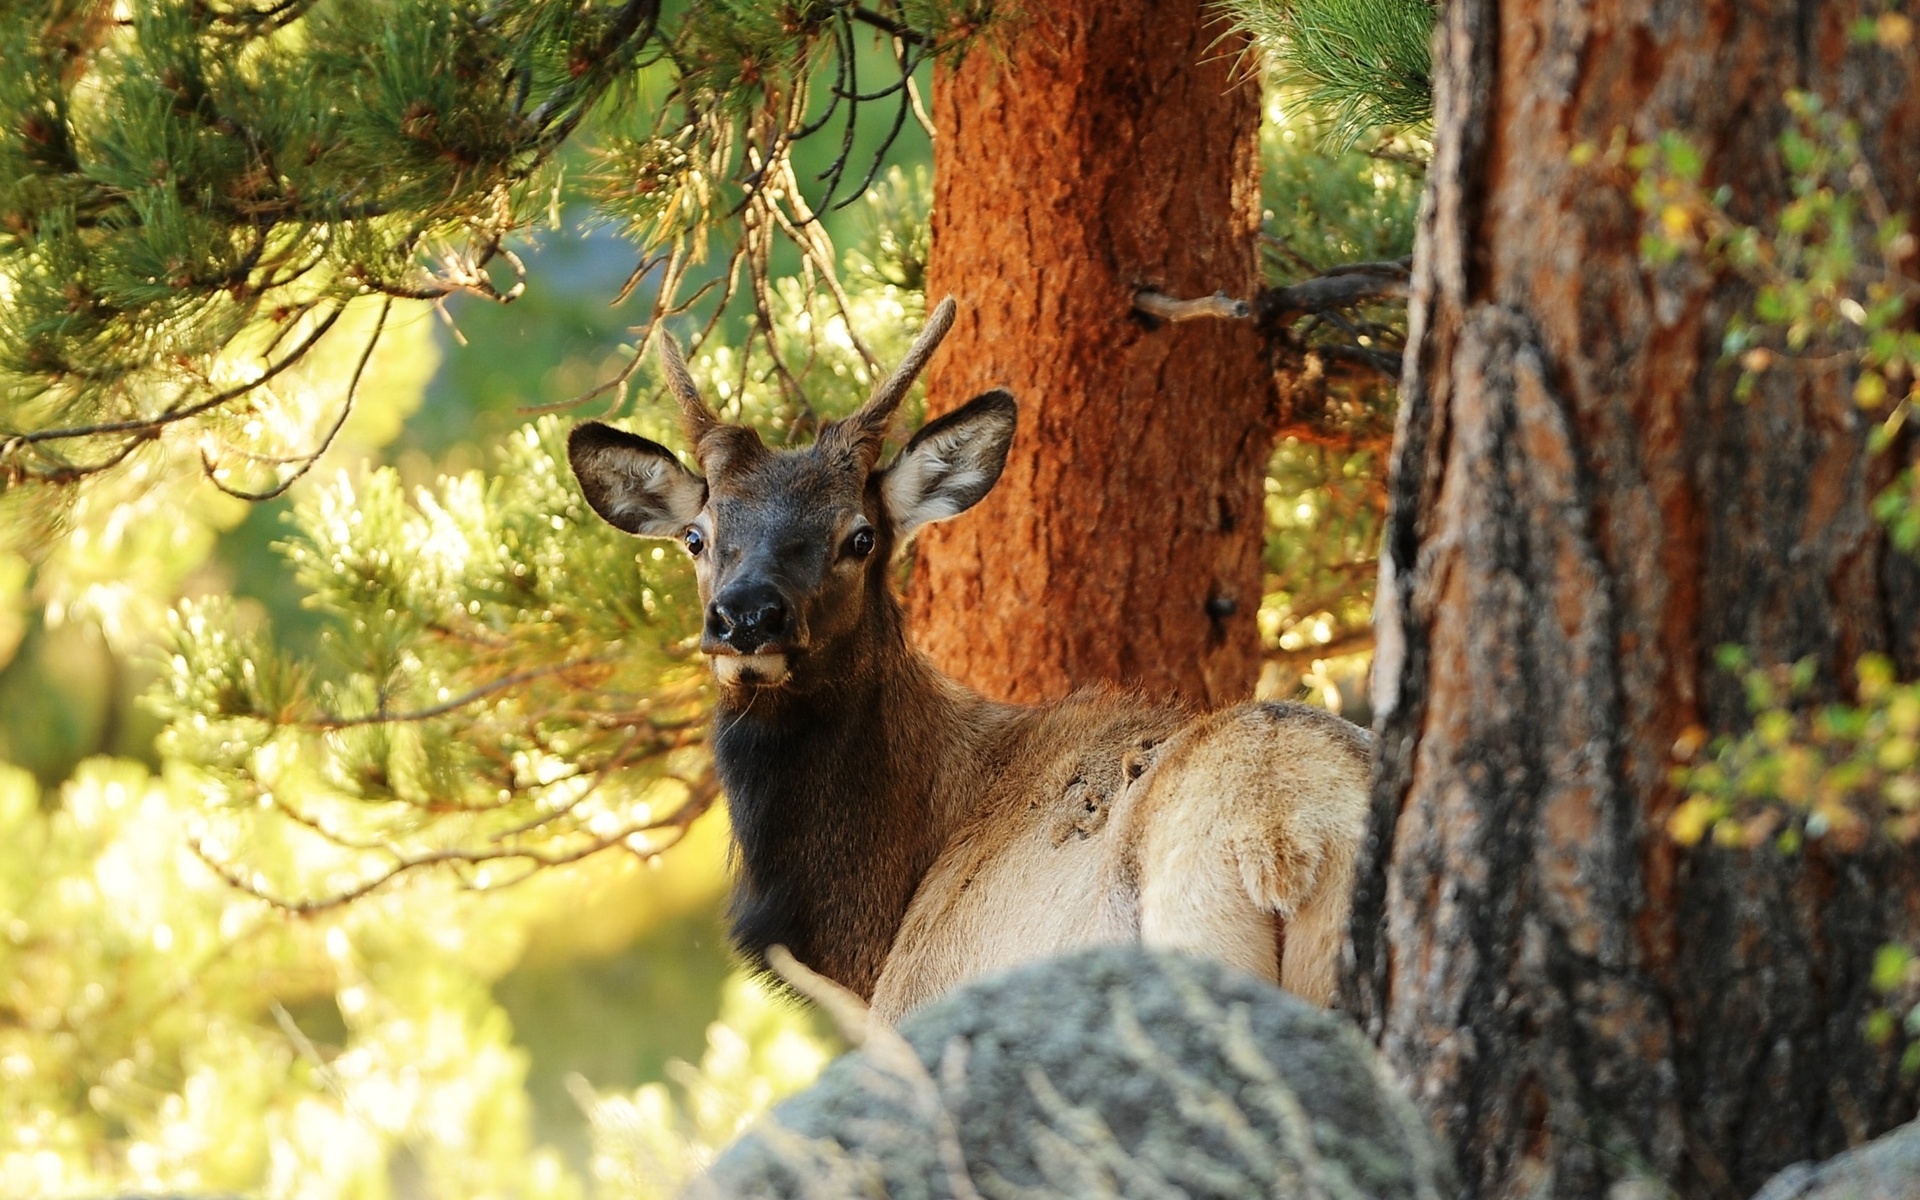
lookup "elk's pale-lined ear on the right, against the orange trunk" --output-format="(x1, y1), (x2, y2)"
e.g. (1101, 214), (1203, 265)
(879, 388), (1020, 541)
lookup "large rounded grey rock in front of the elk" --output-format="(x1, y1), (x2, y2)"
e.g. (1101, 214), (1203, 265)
(685, 947), (1452, 1200)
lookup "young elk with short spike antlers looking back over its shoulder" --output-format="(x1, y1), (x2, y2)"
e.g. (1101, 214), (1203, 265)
(568, 300), (1367, 1020)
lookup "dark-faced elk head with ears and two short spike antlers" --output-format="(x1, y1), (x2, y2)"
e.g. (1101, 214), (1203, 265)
(566, 298), (1016, 691)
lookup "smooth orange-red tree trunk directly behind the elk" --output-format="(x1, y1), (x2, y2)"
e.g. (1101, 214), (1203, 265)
(910, 0), (1277, 703)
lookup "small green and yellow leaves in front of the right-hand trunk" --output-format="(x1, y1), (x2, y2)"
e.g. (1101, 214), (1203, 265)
(1620, 79), (1920, 1075)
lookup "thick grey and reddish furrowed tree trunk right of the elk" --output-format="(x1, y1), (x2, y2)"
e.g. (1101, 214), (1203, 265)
(1348, 0), (1920, 1196)
